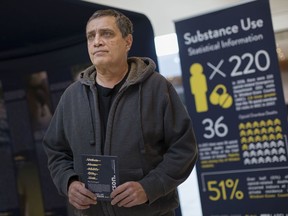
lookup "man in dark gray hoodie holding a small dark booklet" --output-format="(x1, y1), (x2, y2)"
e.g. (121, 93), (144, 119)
(43, 10), (198, 216)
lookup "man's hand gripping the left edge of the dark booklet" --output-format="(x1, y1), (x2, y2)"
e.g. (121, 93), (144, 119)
(68, 181), (97, 209)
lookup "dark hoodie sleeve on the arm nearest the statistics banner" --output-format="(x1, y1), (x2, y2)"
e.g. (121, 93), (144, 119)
(140, 83), (198, 204)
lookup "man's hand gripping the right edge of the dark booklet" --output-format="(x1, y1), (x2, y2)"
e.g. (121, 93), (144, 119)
(111, 182), (148, 207)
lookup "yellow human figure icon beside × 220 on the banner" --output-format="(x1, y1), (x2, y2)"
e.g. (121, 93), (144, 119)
(190, 63), (208, 112)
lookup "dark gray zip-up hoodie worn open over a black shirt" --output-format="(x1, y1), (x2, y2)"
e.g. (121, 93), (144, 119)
(43, 57), (198, 216)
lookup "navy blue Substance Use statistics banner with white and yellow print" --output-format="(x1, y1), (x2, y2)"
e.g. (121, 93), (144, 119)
(175, 0), (288, 216)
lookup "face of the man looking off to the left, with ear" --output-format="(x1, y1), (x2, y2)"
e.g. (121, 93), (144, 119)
(86, 16), (132, 68)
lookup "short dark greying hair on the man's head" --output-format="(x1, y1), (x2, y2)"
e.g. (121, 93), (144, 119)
(86, 9), (133, 37)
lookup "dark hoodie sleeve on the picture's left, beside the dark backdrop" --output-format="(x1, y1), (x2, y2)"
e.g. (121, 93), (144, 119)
(43, 95), (76, 196)
